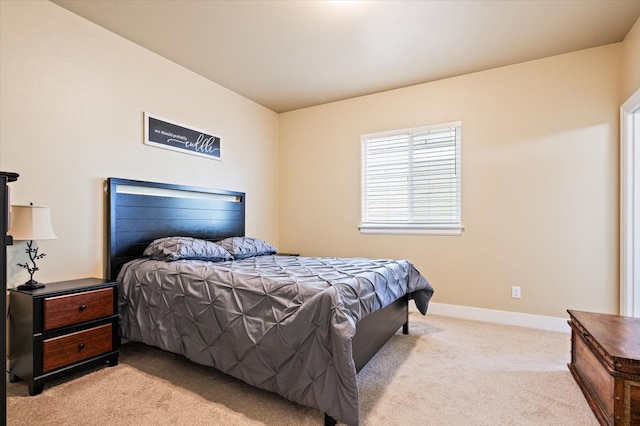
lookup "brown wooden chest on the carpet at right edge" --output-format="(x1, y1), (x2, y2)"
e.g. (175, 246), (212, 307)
(568, 310), (640, 426)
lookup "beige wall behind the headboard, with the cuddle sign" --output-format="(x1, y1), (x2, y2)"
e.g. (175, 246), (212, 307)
(0, 0), (279, 286)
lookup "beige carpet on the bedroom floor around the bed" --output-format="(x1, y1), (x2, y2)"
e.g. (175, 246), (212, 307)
(7, 313), (598, 426)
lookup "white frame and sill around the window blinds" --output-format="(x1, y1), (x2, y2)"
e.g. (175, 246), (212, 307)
(358, 121), (464, 235)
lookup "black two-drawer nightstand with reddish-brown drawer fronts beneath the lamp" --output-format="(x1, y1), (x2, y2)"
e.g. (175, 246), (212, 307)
(9, 278), (120, 395)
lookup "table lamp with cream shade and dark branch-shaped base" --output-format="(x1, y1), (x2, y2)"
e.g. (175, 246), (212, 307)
(8, 203), (58, 290)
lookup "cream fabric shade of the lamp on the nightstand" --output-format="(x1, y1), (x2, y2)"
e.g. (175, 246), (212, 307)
(8, 205), (58, 241)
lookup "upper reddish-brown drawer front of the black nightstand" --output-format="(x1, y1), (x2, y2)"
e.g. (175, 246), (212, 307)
(44, 288), (114, 330)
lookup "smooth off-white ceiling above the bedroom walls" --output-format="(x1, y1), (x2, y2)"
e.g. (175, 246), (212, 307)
(53, 0), (640, 112)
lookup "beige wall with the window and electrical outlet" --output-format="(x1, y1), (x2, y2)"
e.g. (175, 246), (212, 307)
(280, 43), (622, 317)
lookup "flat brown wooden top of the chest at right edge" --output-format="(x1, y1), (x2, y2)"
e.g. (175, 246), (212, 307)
(568, 310), (640, 362)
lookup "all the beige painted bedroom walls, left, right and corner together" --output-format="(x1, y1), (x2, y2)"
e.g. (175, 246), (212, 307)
(0, 0), (640, 317)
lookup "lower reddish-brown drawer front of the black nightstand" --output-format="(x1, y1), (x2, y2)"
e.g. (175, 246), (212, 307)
(42, 324), (113, 372)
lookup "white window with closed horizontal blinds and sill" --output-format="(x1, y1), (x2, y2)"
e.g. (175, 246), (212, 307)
(360, 122), (462, 235)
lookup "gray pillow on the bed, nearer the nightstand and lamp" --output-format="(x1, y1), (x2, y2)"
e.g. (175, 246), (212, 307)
(144, 237), (233, 262)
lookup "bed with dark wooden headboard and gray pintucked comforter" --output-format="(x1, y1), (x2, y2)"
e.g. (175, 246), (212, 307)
(106, 178), (433, 425)
